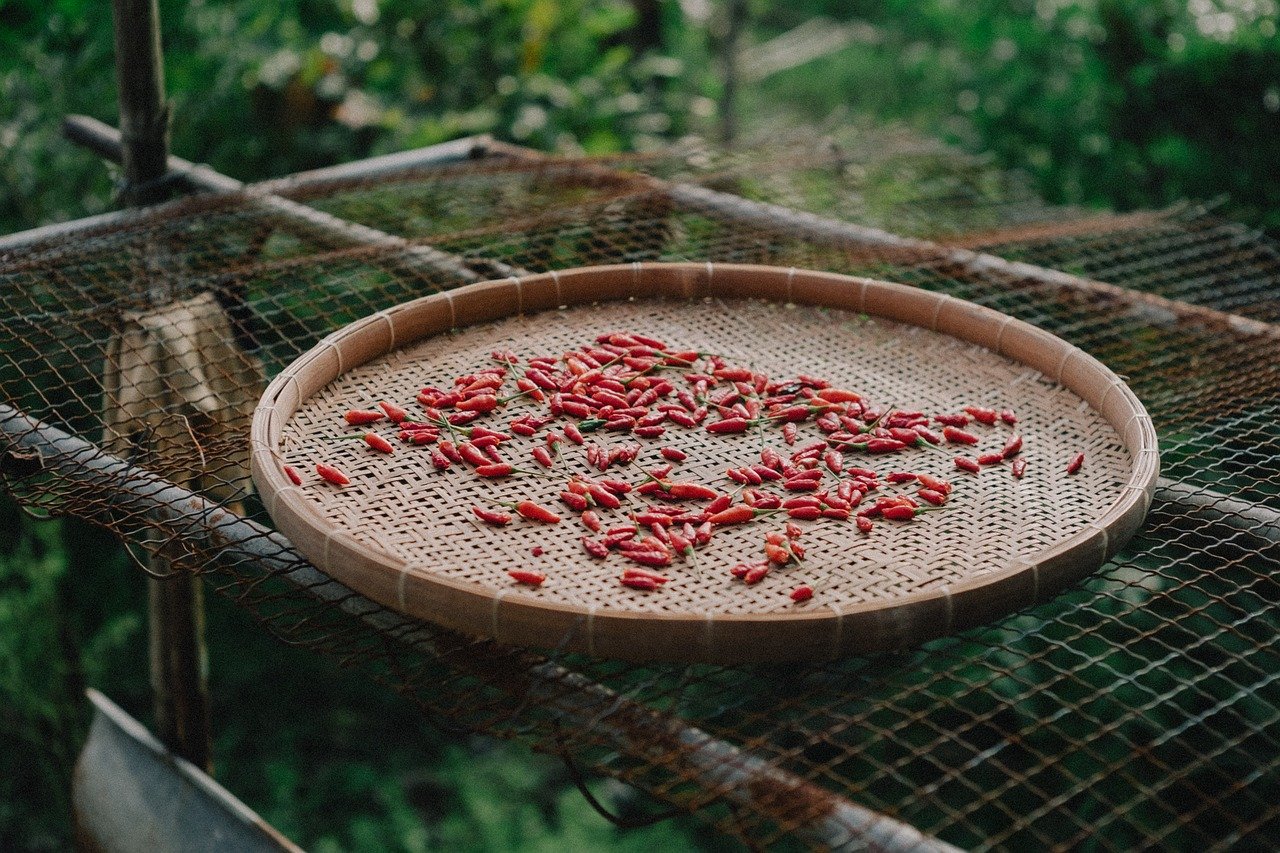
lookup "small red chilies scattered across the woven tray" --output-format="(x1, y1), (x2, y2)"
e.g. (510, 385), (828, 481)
(284, 325), (1084, 602)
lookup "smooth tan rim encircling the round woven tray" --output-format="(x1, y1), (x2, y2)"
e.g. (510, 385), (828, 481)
(250, 261), (1160, 663)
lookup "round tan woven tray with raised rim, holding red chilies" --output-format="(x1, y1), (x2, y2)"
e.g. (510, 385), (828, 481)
(252, 264), (1158, 662)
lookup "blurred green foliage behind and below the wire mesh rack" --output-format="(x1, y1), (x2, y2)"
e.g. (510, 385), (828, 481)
(0, 0), (1280, 850)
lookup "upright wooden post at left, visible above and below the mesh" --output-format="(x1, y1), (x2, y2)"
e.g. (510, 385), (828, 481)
(111, 0), (212, 771)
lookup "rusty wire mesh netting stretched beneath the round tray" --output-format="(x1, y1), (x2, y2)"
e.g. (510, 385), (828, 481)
(0, 132), (1280, 849)
